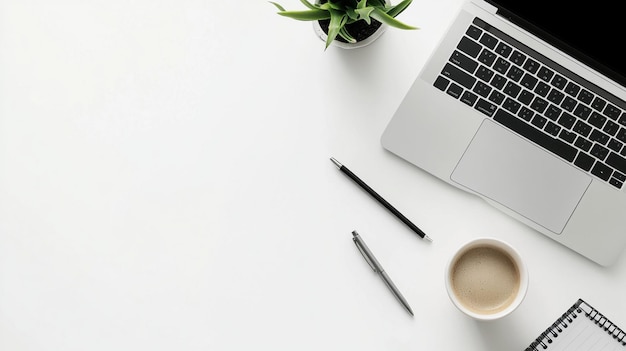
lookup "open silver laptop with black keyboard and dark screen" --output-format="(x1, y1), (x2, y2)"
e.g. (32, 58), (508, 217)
(381, 0), (626, 266)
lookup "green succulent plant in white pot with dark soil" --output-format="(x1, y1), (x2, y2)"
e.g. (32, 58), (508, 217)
(270, 0), (417, 48)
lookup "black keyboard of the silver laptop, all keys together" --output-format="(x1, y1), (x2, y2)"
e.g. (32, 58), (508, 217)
(434, 18), (626, 189)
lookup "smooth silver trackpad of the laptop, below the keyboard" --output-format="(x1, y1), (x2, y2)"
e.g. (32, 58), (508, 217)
(450, 120), (591, 233)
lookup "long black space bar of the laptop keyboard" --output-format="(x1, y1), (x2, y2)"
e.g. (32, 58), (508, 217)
(493, 109), (578, 162)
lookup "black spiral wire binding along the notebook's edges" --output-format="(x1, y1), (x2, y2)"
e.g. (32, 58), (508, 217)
(526, 299), (626, 351)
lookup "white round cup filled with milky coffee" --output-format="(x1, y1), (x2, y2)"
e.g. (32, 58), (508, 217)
(445, 238), (528, 321)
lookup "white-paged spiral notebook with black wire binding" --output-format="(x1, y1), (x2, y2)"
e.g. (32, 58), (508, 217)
(526, 299), (626, 351)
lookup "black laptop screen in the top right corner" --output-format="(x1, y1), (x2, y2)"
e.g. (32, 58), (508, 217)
(486, 0), (626, 87)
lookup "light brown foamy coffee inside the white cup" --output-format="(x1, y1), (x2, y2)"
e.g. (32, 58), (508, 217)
(450, 246), (520, 314)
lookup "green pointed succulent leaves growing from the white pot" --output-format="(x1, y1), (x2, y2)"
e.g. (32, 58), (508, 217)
(270, 0), (417, 48)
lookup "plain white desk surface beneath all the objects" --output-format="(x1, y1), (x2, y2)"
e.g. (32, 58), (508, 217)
(0, 0), (626, 351)
